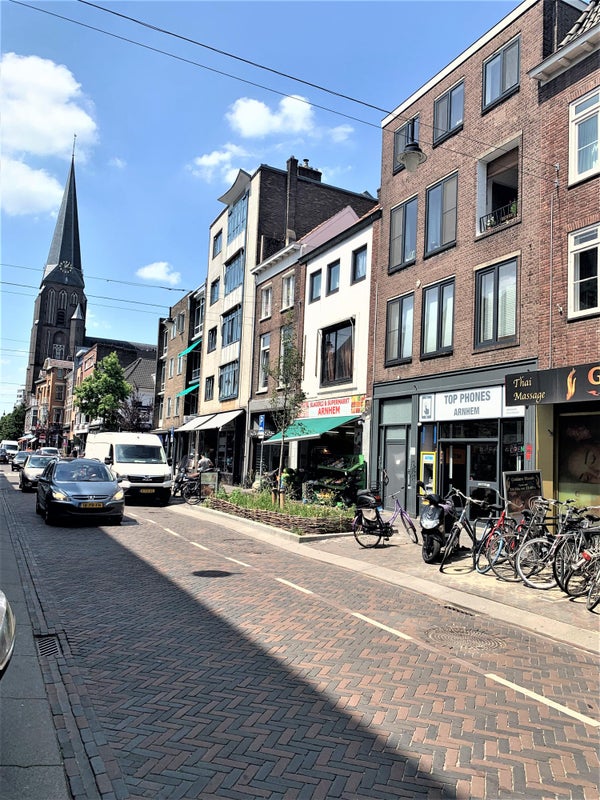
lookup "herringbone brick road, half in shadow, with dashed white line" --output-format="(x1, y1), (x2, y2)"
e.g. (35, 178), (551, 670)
(4, 484), (600, 800)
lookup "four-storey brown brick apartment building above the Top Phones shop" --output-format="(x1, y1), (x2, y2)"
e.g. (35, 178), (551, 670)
(369, 0), (584, 508)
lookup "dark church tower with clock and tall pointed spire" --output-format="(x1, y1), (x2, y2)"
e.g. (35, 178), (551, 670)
(25, 158), (87, 394)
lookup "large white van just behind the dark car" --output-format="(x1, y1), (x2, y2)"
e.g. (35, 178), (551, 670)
(85, 431), (171, 506)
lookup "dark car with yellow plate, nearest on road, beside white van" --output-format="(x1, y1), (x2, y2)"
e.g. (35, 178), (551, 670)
(35, 458), (125, 525)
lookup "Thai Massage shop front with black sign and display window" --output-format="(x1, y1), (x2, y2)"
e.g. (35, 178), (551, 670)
(506, 362), (600, 506)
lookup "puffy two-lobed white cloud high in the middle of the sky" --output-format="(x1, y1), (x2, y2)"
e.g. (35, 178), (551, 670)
(226, 95), (314, 139)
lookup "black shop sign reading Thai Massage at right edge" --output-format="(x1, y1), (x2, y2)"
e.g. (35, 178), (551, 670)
(505, 363), (600, 406)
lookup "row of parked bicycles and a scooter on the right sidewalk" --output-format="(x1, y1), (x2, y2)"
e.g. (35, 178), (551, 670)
(352, 482), (600, 610)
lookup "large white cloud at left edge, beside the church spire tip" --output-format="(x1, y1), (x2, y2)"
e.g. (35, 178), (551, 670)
(0, 53), (98, 214)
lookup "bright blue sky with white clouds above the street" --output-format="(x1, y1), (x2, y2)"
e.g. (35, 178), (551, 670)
(0, 0), (519, 414)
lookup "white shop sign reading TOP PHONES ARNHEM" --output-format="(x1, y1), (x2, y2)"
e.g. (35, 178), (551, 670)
(419, 386), (524, 422)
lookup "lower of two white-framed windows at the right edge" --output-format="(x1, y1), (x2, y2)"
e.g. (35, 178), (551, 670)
(569, 225), (600, 319)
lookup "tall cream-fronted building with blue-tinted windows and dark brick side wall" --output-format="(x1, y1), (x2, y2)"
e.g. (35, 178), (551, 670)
(178, 157), (376, 483)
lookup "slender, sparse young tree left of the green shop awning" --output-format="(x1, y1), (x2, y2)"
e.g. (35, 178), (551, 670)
(267, 313), (306, 485)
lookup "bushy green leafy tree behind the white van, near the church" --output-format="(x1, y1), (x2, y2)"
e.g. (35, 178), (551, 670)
(74, 352), (133, 424)
